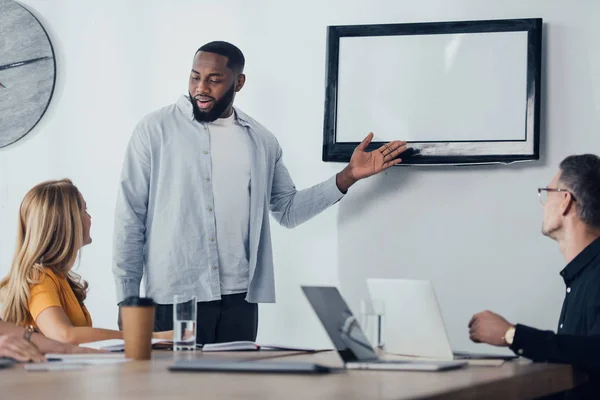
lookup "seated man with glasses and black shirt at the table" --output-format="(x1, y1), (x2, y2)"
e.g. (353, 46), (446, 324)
(469, 154), (600, 395)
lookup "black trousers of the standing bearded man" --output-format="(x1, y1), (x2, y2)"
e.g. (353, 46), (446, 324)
(154, 293), (258, 344)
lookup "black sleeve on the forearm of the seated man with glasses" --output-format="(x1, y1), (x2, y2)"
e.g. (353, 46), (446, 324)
(510, 324), (600, 373)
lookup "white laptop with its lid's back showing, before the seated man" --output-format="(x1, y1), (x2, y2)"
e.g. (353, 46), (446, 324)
(367, 279), (517, 360)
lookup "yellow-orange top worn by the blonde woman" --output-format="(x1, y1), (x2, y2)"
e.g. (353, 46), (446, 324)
(27, 268), (92, 328)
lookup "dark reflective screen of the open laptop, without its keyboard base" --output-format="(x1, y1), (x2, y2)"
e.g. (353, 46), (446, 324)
(302, 286), (378, 362)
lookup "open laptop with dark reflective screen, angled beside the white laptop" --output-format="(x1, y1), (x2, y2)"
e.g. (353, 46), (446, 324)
(302, 286), (467, 371)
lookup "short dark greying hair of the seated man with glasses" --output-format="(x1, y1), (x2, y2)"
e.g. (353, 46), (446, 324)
(559, 154), (600, 228)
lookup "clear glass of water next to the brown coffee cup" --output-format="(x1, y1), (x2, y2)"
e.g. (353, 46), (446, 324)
(173, 295), (196, 351)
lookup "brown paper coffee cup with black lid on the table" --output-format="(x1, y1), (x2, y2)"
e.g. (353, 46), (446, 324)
(120, 297), (155, 360)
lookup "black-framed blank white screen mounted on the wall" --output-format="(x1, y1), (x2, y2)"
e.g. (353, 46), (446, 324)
(323, 18), (542, 165)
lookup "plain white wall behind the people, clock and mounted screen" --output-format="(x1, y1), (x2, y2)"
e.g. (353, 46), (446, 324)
(0, 0), (600, 349)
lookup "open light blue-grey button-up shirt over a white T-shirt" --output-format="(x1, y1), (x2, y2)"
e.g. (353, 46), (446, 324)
(113, 96), (343, 304)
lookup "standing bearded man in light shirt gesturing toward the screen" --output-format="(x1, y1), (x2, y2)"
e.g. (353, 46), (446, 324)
(113, 42), (406, 343)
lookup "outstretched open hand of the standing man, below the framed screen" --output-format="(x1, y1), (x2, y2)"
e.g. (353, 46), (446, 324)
(337, 133), (406, 193)
